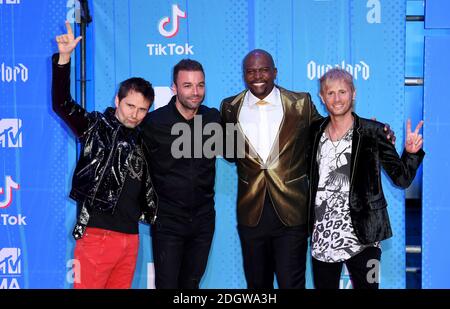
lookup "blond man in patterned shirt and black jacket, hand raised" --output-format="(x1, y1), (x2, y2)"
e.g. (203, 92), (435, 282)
(310, 68), (425, 289)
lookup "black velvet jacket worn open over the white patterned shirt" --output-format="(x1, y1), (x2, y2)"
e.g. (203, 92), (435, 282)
(309, 113), (425, 244)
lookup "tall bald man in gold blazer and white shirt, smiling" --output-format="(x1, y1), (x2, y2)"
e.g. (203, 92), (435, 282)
(221, 49), (321, 288)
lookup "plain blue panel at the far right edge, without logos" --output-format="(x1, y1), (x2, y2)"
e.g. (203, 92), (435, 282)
(422, 0), (450, 288)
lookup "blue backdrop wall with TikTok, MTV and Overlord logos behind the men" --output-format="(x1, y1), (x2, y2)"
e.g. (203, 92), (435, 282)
(0, 0), (428, 288)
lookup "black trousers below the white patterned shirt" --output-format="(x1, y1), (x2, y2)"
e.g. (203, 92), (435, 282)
(312, 247), (381, 289)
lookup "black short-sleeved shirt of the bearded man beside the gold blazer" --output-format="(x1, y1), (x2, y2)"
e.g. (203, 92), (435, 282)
(143, 96), (221, 218)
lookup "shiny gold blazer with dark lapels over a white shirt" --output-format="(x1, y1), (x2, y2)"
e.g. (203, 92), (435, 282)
(221, 86), (321, 226)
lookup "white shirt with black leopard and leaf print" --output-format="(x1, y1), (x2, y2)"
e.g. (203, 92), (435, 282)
(311, 128), (378, 263)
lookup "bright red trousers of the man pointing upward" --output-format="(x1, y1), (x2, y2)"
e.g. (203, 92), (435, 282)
(73, 227), (139, 289)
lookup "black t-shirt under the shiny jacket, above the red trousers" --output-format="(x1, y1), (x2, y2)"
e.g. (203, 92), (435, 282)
(87, 151), (146, 234)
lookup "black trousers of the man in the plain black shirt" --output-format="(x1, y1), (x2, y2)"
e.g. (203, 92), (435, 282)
(152, 210), (215, 289)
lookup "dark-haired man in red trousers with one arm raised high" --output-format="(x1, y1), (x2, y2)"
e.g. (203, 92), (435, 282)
(52, 22), (157, 288)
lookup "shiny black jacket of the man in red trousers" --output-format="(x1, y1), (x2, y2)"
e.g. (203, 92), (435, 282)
(52, 54), (157, 239)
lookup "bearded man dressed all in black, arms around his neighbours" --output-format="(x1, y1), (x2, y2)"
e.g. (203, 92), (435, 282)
(143, 59), (222, 289)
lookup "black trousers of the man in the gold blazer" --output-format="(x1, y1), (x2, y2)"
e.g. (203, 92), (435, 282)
(238, 195), (308, 289)
